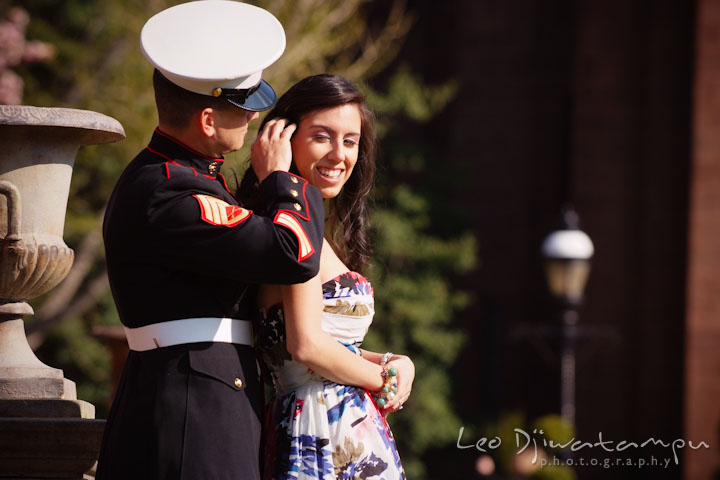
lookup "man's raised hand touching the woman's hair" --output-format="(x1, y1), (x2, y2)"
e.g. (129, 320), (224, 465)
(250, 118), (297, 183)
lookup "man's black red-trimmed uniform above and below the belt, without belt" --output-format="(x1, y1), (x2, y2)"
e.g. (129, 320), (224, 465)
(97, 130), (324, 480)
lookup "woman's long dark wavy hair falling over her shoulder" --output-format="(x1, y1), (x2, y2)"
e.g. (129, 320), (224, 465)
(236, 74), (377, 272)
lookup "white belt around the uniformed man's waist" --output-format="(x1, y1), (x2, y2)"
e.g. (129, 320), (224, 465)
(125, 317), (253, 352)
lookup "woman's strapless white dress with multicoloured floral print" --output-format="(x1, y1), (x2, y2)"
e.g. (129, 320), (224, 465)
(255, 272), (405, 480)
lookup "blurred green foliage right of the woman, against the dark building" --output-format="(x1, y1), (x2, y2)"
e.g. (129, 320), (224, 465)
(366, 68), (475, 478)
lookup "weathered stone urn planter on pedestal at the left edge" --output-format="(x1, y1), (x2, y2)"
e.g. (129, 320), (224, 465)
(0, 105), (125, 479)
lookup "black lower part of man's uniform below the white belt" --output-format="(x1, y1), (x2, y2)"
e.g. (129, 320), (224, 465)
(98, 343), (263, 480)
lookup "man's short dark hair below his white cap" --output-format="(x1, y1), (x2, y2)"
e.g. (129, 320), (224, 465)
(153, 69), (232, 127)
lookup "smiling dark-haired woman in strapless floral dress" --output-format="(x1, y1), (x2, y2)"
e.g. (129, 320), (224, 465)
(238, 75), (415, 480)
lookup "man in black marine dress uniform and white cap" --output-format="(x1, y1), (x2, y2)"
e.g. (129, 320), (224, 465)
(97, 0), (324, 480)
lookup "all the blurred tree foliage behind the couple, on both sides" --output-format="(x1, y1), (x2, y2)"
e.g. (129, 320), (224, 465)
(7, 0), (475, 479)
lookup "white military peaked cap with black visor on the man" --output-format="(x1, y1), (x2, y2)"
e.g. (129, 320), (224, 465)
(140, 0), (285, 112)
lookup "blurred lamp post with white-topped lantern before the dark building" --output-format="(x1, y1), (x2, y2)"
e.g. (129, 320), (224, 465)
(542, 208), (594, 425)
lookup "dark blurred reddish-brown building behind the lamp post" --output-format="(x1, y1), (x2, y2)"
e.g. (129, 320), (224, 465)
(400, 0), (720, 479)
